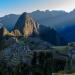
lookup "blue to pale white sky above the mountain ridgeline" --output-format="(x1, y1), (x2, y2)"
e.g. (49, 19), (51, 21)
(0, 0), (75, 16)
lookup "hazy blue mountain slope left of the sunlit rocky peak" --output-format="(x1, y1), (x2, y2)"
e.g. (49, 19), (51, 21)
(0, 14), (19, 31)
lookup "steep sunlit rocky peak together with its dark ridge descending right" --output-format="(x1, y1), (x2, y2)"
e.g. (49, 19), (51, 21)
(0, 11), (65, 45)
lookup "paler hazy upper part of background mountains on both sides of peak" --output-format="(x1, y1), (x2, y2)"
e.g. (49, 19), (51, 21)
(0, 10), (75, 29)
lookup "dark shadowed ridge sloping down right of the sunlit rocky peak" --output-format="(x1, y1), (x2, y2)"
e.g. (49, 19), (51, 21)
(39, 25), (66, 45)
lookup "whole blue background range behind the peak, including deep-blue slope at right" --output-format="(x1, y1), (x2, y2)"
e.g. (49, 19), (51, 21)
(0, 10), (75, 42)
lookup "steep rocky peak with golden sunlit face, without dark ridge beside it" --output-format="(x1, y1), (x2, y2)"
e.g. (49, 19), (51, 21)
(14, 12), (38, 37)
